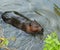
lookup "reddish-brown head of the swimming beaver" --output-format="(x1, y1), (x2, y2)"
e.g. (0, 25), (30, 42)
(26, 20), (43, 34)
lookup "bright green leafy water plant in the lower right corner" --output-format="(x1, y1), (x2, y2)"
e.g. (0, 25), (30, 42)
(43, 32), (60, 50)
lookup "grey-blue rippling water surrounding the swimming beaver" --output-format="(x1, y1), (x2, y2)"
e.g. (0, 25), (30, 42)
(0, 0), (60, 50)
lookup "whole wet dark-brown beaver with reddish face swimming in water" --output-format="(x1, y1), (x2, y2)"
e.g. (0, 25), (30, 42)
(1, 11), (44, 35)
